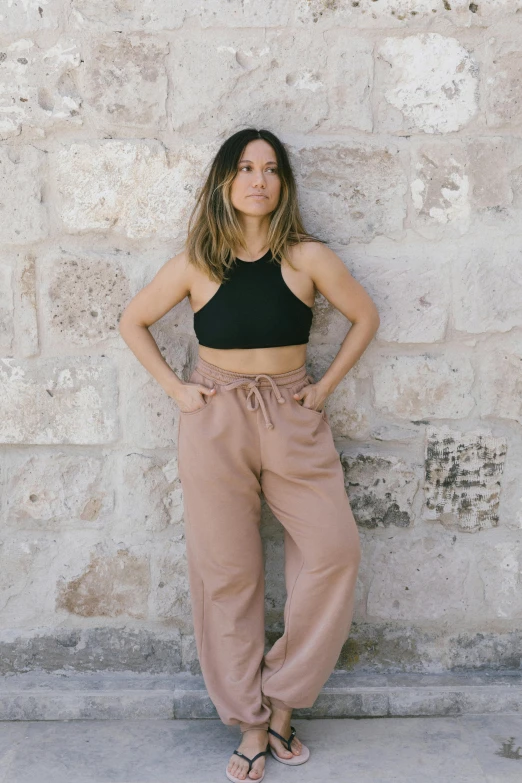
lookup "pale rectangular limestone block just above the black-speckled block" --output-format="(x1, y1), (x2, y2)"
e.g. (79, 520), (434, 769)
(373, 354), (475, 419)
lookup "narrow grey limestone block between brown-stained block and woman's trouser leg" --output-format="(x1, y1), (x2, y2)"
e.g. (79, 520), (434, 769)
(151, 541), (194, 634)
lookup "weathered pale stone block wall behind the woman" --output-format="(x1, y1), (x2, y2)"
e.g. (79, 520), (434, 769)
(0, 0), (522, 672)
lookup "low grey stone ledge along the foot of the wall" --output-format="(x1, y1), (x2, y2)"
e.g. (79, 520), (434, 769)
(0, 670), (522, 721)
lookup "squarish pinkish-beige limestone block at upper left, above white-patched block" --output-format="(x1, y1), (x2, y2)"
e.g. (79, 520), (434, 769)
(82, 33), (168, 133)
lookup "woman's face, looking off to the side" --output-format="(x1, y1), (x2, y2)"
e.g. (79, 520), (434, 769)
(230, 139), (281, 217)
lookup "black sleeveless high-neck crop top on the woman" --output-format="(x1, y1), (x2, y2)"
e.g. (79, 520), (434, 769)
(194, 250), (313, 348)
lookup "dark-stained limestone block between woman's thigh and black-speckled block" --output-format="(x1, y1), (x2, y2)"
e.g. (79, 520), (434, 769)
(341, 452), (419, 529)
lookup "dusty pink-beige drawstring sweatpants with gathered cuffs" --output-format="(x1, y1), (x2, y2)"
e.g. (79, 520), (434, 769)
(178, 357), (360, 731)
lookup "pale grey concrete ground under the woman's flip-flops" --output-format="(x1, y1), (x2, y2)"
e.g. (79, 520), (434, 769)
(0, 713), (522, 783)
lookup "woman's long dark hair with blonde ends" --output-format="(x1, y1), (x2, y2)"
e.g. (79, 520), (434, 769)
(181, 128), (323, 283)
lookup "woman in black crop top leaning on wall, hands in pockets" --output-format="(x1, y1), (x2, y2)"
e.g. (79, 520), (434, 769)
(119, 128), (379, 781)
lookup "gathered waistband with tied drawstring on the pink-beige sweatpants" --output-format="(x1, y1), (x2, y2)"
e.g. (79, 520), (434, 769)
(195, 357), (313, 430)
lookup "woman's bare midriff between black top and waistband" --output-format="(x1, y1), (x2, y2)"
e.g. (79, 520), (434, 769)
(198, 343), (307, 375)
